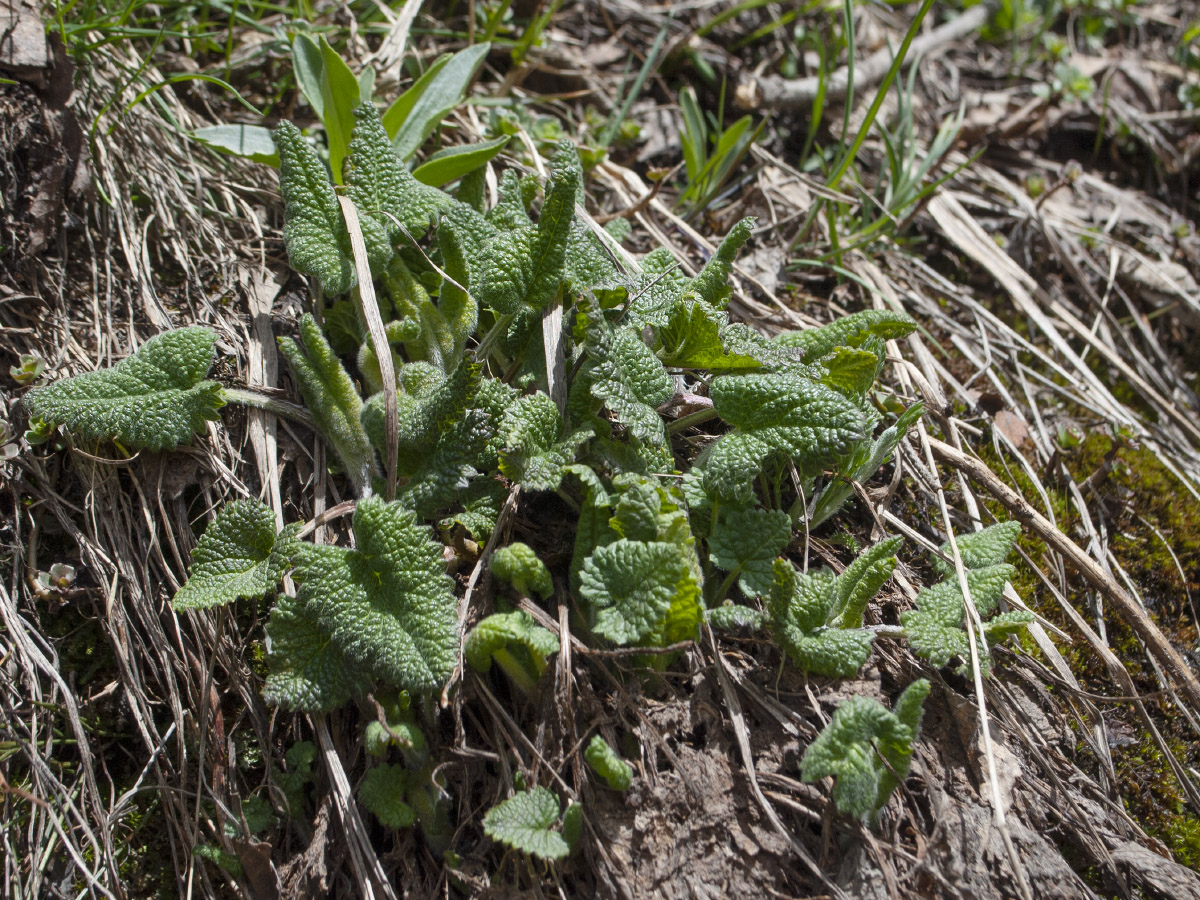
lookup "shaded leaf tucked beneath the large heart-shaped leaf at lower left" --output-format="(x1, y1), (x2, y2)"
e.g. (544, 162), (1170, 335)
(263, 596), (368, 713)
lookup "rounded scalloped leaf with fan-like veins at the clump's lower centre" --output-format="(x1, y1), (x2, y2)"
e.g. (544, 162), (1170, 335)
(580, 539), (703, 647)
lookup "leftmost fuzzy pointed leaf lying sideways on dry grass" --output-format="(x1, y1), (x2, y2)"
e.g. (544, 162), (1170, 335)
(25, 328), (224, 450)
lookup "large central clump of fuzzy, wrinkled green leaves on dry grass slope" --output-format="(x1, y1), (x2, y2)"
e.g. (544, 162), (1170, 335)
(29, 116), (926, 686)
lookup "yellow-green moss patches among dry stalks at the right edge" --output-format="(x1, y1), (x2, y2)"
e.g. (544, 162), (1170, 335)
(979, 433), (1200, 868)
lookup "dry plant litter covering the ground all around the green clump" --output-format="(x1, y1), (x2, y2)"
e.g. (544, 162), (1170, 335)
(0, 0), (1200, 898)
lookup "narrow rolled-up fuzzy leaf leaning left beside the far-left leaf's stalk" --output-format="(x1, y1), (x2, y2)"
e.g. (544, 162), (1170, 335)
(280, 313), (376, 492)
